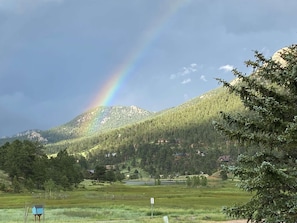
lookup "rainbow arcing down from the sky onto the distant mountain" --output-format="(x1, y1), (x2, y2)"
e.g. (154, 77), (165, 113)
(83, 0), (191, 134)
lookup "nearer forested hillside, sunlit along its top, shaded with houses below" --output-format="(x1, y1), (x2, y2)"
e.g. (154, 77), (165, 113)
(46, 88), (242, 175)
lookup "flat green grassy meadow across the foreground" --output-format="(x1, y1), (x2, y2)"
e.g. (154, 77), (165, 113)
(0, 179), (250, 223)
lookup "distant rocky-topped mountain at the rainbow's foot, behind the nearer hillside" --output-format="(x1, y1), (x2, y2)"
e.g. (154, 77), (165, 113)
(0, 105), (156, 145)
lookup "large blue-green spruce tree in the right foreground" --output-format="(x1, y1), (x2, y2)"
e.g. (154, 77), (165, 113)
(215, 45), (297, 223)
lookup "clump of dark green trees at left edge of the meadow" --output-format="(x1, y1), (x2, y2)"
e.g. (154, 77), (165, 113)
(0, 140), (83, 192)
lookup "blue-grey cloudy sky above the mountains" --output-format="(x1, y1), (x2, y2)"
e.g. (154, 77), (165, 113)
(0, 0), (297, 137)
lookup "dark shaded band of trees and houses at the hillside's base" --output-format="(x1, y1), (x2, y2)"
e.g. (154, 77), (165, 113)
(88, 142), (234, 178)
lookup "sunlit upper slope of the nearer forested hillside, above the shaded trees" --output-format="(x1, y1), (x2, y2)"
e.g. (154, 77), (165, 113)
(47, 88), (242, 156)
